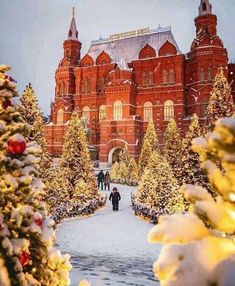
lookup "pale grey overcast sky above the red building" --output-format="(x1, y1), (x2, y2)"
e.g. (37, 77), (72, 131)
(0, 0), (235, 114)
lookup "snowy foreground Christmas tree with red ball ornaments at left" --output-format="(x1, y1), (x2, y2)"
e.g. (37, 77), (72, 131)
(0, 66), (71, 286)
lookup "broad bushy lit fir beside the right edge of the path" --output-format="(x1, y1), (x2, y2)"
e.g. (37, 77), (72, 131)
(135, 151), (184, 220)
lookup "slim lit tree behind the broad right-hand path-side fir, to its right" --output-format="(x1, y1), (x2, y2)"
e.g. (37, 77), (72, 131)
(163, 119), (181, 179)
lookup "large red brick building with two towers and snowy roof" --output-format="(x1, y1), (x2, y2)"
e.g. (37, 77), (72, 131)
(45, 0), (235, 163)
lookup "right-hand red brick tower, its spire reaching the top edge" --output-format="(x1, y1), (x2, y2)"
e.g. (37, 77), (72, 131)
(186, 0), (228, 118)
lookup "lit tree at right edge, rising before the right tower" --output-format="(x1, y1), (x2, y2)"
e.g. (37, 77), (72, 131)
(204, 68), (234, 132)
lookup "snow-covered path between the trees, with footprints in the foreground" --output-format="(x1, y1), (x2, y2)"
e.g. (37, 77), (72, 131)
(57, 185), (160, 286)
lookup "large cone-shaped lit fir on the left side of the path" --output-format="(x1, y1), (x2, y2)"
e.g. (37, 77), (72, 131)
(47, 112), (105, 221)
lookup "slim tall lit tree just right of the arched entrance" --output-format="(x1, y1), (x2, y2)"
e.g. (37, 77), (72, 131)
(139, 120), (159, 176)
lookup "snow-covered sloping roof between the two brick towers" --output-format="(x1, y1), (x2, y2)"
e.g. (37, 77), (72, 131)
(88, 27), (180, 67)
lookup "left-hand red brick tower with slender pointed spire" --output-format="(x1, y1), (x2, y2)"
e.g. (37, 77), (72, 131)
(45, 7), (82, 155)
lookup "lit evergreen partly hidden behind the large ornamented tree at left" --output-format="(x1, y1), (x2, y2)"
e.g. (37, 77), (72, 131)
(21, 83), (51, 179)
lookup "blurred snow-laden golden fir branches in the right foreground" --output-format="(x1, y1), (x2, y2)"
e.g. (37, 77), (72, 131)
(149, 118), (235, 286)
